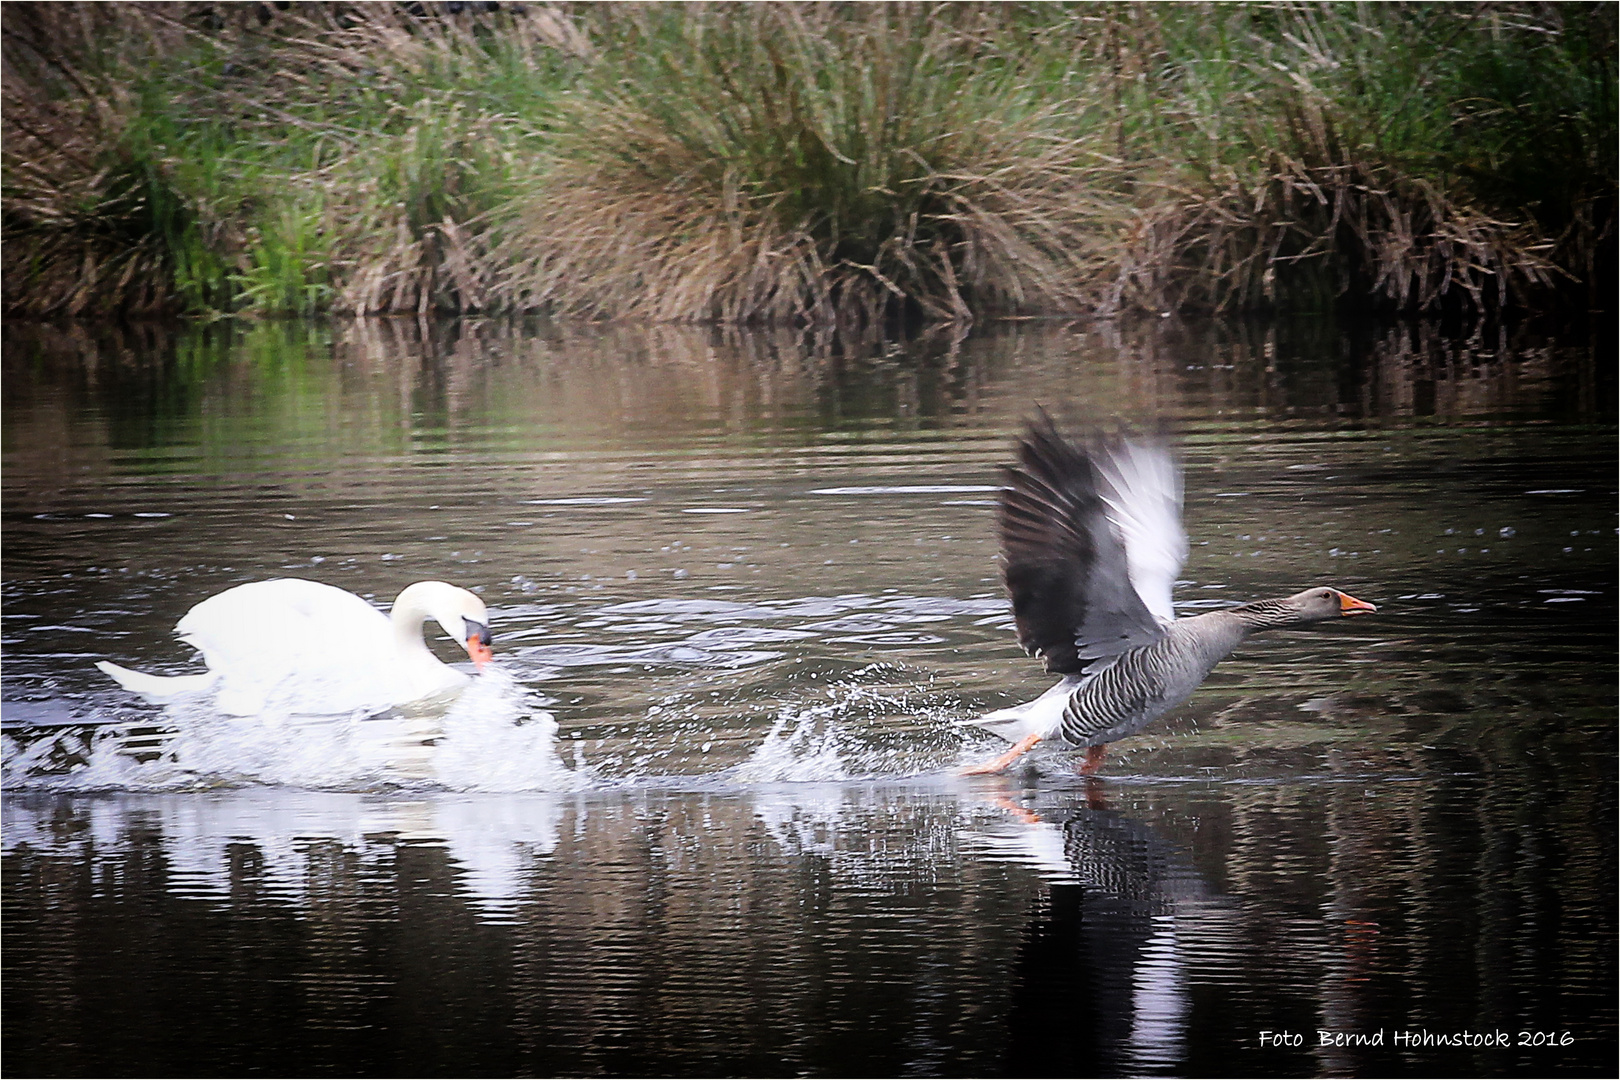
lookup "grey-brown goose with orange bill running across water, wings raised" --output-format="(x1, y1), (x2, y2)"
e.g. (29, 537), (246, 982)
(964, 415), (1377, 774)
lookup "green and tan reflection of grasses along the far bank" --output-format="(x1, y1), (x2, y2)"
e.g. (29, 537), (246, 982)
(5, 312), (1614, 472)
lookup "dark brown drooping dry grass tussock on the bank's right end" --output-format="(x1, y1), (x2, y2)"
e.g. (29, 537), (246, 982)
(1110, 110), (1571, 313)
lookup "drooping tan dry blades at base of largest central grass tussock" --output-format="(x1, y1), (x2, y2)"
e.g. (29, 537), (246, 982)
(496, 108), (1118, 322)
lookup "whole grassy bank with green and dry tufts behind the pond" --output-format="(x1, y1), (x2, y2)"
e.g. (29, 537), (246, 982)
(3, 3), (1617, 322)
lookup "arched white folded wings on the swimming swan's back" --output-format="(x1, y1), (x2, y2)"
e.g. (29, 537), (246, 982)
(175, 578), (395, 716)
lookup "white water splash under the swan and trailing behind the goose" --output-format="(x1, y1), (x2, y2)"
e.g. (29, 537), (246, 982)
(5, 661), (984, 792)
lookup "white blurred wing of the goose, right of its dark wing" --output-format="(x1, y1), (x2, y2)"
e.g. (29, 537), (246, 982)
(1092, 439), (1187, 622)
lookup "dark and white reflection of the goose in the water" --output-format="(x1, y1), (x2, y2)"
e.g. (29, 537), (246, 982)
(967, 782), (1239, 1075)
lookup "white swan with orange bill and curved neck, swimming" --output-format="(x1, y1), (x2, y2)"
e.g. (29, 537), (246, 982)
(96, 578), (491, 716)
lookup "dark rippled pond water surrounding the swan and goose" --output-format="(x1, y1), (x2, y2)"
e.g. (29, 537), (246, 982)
(0, 322), (1617, 1075)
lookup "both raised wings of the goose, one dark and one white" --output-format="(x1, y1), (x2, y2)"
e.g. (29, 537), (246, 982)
(1000, 421), (1186, 674)
